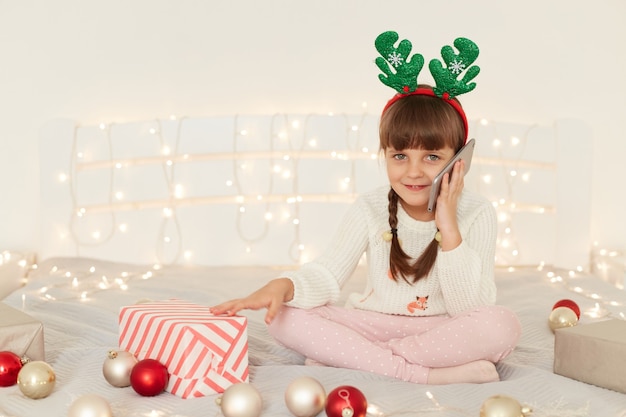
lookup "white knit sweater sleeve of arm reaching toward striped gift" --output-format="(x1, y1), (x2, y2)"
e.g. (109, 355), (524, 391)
(283, 199), (367, 308)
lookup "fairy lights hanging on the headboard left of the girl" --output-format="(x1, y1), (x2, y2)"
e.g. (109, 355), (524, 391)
(61, 115), (378, 263)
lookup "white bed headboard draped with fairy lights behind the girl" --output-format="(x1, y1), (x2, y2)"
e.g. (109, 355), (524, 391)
(39, 114), (591, 268)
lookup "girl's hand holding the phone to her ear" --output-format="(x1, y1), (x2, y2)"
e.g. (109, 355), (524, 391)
(435, 159), (465, 250)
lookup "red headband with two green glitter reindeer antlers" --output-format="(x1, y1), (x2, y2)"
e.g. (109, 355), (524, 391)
(374, 31), (480, 140)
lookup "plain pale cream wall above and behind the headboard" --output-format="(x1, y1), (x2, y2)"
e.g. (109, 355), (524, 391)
(0, 0), (626, 251)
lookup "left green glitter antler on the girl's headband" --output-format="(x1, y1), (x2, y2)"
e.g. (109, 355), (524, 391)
(374, 31), (424, 93)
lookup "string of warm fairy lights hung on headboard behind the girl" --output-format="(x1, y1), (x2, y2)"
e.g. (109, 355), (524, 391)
(67, 115), (554, 263)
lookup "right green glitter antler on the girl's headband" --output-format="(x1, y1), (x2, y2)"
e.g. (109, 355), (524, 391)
(428, 38), (480, 98)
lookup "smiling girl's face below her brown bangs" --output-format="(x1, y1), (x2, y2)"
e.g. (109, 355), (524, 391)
(385, 147), (454, 220)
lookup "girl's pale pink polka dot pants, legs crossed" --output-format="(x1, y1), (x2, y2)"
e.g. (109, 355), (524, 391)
(269, 306), (521, 384)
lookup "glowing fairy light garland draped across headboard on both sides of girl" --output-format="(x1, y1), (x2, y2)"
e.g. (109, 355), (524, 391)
(59, 114), (556, 264)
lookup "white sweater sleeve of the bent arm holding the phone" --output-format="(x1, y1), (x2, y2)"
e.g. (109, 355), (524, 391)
(436, 197), (498, 316)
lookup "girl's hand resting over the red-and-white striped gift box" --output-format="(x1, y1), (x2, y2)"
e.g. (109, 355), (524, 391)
(211, 278), (294, 324)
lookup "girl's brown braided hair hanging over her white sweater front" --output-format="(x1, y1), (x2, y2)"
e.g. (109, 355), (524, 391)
(388, 188), (439, 283)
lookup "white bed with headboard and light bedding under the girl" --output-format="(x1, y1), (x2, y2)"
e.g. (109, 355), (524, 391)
(0, 114), (626, 417)
